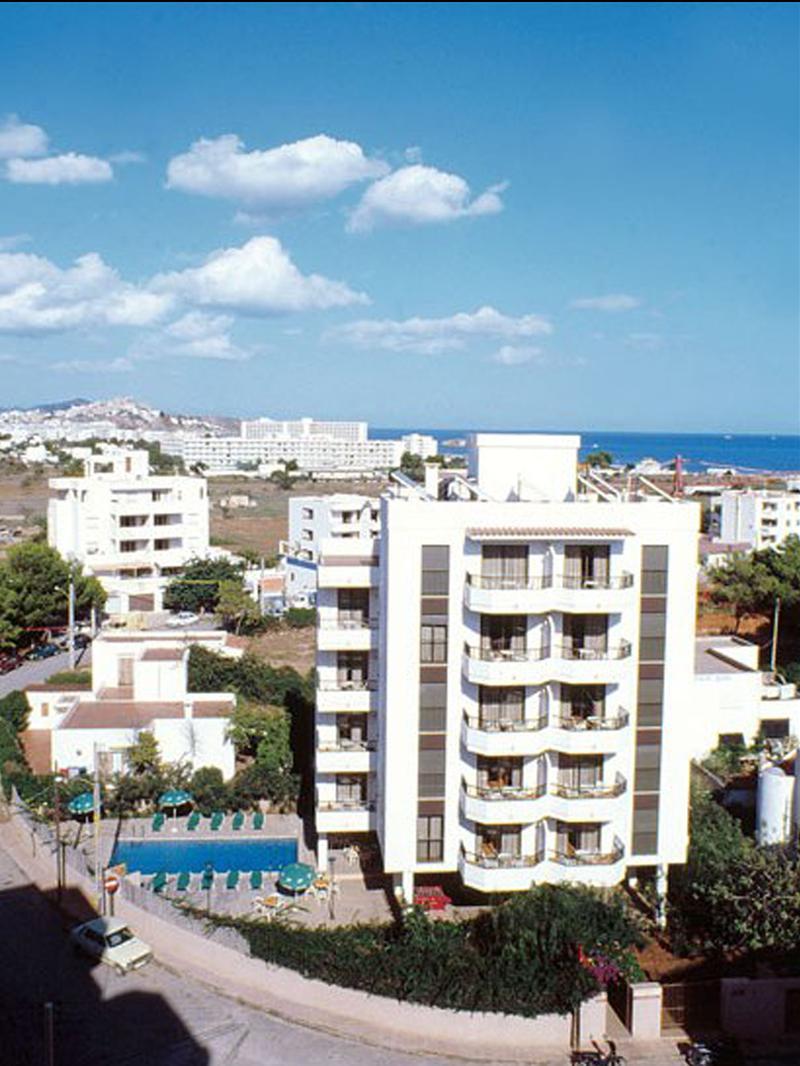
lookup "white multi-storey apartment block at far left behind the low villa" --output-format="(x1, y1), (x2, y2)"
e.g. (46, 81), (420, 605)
(47, 449), (209, 614)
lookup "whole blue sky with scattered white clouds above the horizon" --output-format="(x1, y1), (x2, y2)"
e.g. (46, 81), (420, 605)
(0, 3), (800, 433)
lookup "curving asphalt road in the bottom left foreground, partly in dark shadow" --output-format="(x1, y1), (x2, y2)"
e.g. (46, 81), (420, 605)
(0, 851), (501, 1066)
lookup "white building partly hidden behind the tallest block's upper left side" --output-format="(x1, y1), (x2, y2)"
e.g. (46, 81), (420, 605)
(279, 492), (381, 603)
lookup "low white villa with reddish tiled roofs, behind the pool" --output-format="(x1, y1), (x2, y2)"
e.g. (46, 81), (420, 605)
(22, 630), (236, 778)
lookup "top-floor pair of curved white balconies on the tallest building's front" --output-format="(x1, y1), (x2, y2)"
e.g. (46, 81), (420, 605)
(464, 572), (634, 614)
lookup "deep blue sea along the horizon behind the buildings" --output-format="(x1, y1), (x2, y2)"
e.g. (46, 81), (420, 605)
(370, 427), (800, 473)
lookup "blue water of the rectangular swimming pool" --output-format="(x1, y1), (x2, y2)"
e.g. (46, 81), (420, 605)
(110, 838), (298, 873)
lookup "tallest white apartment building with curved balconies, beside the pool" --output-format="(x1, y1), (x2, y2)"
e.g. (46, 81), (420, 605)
(316, 434), (700, 899)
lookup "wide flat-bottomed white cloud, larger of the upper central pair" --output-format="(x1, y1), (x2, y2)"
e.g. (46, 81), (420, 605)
(166, 133), (388, 211)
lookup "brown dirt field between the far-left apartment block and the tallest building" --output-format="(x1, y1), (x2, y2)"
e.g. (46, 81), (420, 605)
(208, 475), (386, 555)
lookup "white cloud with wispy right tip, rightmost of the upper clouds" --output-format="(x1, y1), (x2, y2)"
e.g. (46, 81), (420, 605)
(348, 163), (507, 233)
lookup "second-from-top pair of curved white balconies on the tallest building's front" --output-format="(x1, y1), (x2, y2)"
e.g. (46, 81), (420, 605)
(463, 641), (631, 685)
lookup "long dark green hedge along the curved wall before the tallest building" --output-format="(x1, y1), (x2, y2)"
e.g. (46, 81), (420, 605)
(208, 885), (640, 1017)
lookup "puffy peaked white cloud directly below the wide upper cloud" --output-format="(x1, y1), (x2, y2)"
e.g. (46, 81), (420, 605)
(151, 237), (369, 316)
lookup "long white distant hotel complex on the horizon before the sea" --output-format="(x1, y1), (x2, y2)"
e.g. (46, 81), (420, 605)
(163, 418), (438, 478)
